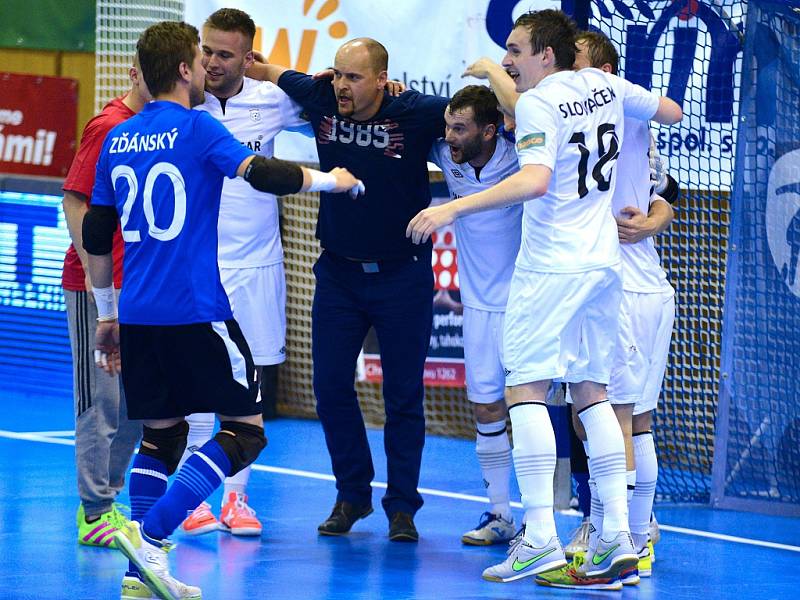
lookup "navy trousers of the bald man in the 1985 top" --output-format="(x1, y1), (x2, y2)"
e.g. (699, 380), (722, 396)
(312, 251), (433, 518)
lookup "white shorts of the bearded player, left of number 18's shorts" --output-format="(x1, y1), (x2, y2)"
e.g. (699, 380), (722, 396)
(463, 306), (506, 404)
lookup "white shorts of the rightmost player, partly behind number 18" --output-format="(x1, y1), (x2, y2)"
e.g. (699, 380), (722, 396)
(608, 292), (675, 412)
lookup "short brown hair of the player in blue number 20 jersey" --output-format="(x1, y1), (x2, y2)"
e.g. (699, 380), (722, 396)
(136, 21), (200, 97)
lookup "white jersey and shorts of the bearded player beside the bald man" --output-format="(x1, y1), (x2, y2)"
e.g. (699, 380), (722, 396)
(430, 136), (522, 404)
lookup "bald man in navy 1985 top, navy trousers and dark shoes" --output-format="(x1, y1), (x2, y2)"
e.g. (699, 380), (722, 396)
(253, 38), (447, 541)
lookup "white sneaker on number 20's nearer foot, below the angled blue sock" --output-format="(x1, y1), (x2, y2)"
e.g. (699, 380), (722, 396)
(114, 521), (202, 600)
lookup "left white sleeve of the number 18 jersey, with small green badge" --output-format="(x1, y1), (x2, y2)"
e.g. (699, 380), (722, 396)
(514, 92), (558, 170)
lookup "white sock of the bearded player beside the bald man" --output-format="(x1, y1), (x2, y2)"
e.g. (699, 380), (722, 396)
(475, 419), (511, 521)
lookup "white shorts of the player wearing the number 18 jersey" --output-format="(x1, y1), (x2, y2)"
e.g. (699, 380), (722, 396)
(503, 266), (622, 386)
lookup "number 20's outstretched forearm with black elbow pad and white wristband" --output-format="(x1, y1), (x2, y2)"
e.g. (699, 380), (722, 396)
(236, 155), (365, 197)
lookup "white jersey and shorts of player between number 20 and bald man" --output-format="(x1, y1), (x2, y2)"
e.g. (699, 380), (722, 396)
(196, 77), (307, 365)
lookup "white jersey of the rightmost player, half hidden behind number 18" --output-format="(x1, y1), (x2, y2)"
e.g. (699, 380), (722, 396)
(611, 118), (674, 293)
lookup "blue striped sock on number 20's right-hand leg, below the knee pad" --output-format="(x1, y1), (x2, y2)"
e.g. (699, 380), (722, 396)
(142, 439), (231, 540)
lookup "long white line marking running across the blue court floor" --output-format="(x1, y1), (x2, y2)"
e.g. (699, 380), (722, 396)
(0, 429), (800, 552)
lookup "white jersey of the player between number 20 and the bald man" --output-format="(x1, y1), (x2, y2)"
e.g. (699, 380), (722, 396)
(195, 77), (308, 269)
